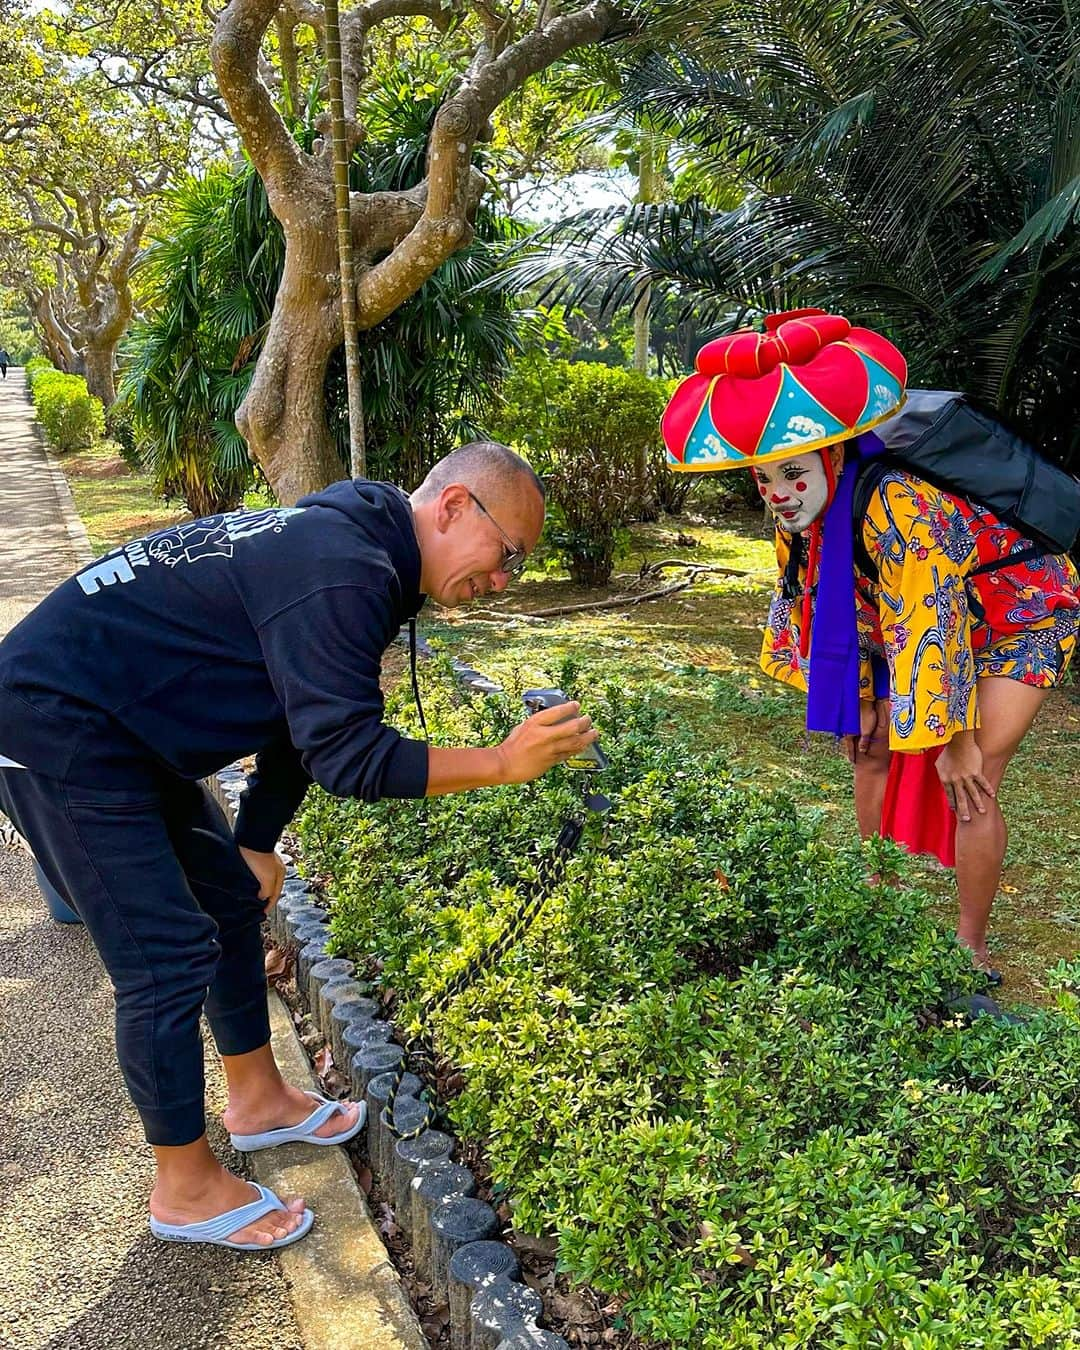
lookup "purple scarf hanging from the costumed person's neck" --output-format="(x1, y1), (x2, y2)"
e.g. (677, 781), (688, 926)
(806, 431), (886, 736)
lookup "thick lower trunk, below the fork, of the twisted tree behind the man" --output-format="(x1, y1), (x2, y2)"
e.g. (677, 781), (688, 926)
(236, 229), (344, 506)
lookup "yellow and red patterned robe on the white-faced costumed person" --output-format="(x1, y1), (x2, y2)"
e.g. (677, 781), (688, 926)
(761, 470), (1080, 751)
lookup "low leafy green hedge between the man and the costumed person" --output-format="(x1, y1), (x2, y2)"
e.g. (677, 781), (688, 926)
(298, 658), (1080, 1350)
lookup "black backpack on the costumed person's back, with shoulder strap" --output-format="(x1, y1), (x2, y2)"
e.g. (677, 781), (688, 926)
(852, 389), (1080, 578)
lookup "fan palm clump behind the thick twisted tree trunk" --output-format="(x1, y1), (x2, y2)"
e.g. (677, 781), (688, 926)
(120, 59), (520, 502)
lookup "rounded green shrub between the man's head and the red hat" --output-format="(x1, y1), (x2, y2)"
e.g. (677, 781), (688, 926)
(495, 356), (668, 586)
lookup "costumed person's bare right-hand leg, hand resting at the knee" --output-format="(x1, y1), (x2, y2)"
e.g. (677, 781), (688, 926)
(956, 678), (1049, 968)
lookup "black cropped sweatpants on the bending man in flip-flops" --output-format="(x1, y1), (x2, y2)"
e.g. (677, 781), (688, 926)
(0, 768), (270, 1145)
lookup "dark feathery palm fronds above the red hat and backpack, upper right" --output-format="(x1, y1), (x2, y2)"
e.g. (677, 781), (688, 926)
(509, 0), (1080, 475)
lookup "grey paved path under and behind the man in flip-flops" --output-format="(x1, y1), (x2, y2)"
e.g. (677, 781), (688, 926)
(0, 370), (302, 1350)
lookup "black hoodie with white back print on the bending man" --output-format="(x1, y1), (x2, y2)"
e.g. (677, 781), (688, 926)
(0, 479), (428, 848)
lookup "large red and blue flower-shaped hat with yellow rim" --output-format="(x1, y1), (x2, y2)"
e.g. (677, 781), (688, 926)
(660, 309), (907, 473)
